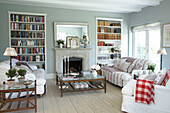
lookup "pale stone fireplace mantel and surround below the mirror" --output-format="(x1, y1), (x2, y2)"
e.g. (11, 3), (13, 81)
(54, 48), (91, 73)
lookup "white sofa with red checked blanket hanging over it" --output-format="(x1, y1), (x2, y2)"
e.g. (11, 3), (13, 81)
(121, 75), (170, 113)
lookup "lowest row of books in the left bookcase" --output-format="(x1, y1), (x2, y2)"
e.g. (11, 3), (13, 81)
(14, 55), (45, 62)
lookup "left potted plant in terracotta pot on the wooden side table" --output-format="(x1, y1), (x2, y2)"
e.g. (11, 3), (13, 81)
(5, 68), (17, 87)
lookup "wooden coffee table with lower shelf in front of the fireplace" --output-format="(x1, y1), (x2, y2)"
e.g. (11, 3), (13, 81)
(56, 73), (106, 97)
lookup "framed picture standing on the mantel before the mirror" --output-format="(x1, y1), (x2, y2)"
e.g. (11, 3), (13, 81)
(67, 36), (80, 48)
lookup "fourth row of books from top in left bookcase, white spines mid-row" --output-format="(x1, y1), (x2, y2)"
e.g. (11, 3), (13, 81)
(11, 39), (45, 46)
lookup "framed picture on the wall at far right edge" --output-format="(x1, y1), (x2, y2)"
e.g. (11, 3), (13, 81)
(162, 23), (170, 48)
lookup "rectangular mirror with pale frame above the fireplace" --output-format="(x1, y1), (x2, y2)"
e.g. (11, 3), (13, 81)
(54, 22), (90, 47)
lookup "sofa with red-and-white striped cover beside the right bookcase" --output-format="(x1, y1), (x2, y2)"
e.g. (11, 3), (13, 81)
(101, 57), (150, 87)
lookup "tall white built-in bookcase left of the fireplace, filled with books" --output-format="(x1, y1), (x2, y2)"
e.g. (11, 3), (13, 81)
(8, 12), (46, 69)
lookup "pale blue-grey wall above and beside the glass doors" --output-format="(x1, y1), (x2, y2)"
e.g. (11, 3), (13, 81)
(129, 0), (170, 69)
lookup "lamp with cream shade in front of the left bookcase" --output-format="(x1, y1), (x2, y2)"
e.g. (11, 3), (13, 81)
(3, 47), (17, 69)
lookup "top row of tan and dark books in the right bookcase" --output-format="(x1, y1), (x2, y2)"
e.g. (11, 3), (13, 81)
(97, 21), (121, 27)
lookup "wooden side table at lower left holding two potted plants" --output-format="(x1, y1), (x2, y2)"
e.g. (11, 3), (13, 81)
(0, 81), (37, 112)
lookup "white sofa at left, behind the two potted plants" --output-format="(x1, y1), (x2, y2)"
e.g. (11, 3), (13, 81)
(0, 59), (46, 96)
